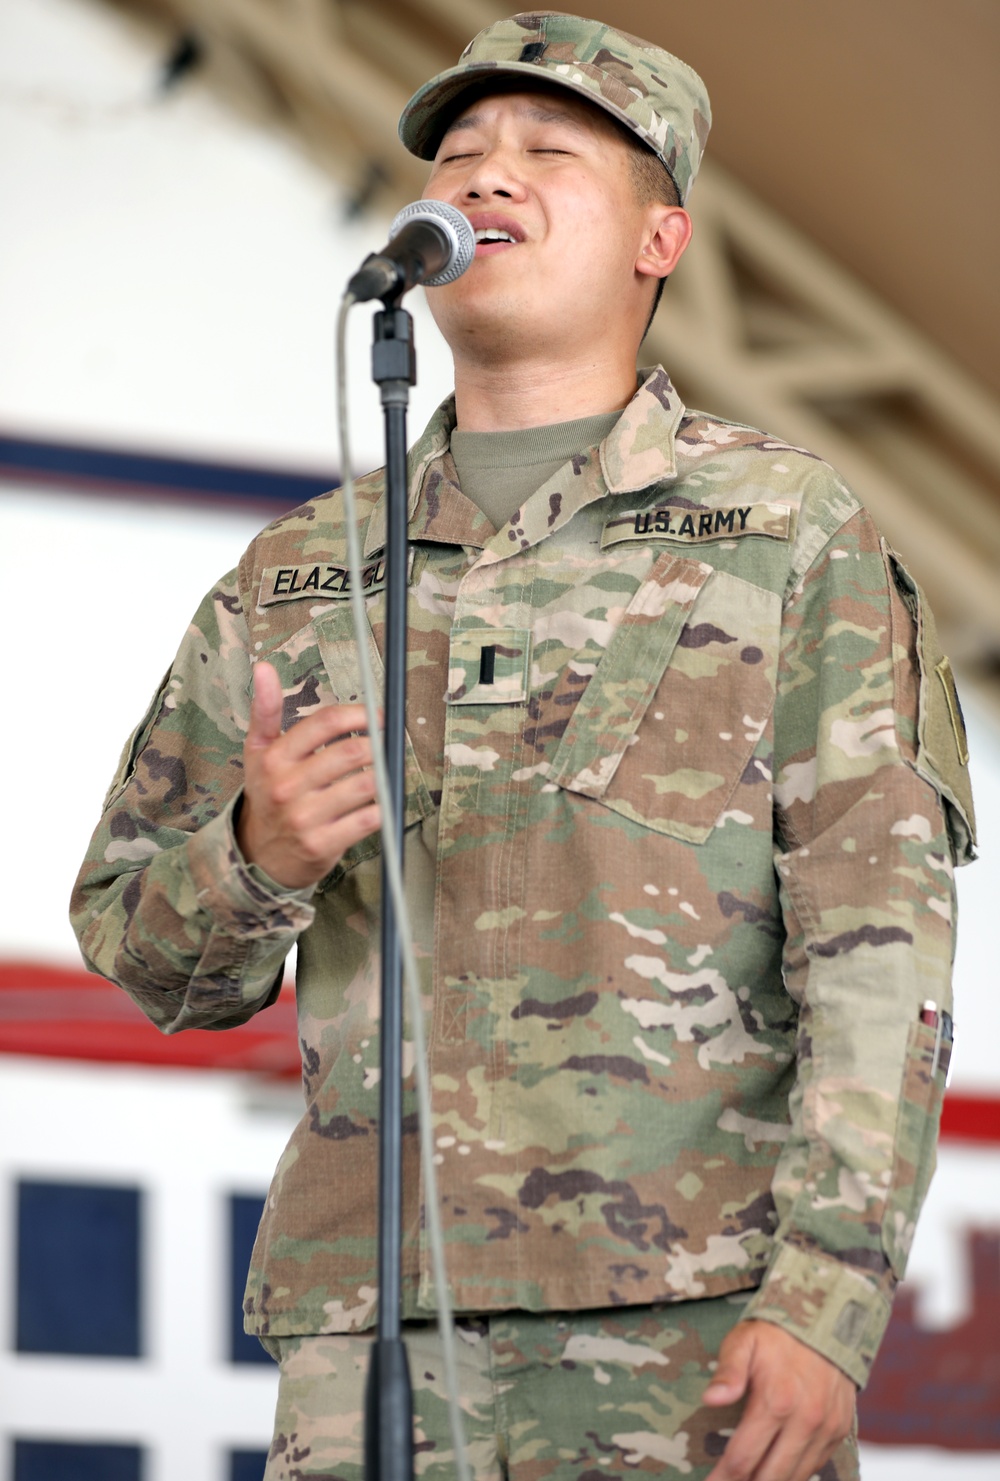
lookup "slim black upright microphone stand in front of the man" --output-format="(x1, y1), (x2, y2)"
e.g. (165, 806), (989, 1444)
(365, 293), (416, 1481)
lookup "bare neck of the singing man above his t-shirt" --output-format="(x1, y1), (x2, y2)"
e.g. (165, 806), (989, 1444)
(455, 354), (636, 432)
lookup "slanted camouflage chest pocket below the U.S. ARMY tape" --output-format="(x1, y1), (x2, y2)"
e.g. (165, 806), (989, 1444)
(550, 554), (781, 843)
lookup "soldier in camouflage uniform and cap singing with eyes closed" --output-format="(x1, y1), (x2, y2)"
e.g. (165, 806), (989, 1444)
(74, 13), (973, 1481)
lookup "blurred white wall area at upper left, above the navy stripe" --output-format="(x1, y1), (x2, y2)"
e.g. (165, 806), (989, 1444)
(0, 0), (452, 469)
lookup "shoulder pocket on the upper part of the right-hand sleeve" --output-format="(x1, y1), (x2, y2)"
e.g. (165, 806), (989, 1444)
(881, 541), (976, 863)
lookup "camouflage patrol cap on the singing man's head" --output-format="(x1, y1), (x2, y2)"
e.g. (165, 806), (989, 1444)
(400, 10), (711, 203)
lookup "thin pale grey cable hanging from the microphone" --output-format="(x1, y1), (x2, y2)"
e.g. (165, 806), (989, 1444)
(335, 292), (473, 1481)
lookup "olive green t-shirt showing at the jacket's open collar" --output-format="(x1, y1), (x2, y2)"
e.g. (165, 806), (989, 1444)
(452, 412), (622, 530)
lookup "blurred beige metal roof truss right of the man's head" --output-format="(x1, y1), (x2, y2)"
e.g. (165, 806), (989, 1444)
(644, 164), (1000, 662)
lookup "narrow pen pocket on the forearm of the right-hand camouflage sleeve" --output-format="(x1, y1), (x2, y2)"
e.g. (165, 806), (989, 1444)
(881, 1019), (951, 1280)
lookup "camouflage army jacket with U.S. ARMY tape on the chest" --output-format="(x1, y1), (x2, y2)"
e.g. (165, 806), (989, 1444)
(74, 370), (972, 1382)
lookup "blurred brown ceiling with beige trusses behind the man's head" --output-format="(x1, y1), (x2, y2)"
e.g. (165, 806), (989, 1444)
(111, 0), (1000, 703)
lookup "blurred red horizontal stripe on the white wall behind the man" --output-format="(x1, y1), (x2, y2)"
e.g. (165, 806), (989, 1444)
(0, 961), (1000, 1146)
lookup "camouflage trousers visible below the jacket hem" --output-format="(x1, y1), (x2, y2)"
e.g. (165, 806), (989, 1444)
(264, 1294), (858, 1481)
